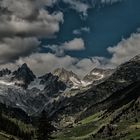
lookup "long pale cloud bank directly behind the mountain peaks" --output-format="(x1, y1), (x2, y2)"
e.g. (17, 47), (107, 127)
(1, 53), (101, 77)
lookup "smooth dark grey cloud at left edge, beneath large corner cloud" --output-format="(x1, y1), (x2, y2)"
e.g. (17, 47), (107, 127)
(0, 37), (40, 64)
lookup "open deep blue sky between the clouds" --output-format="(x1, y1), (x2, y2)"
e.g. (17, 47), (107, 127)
(43, 0), (140, 58)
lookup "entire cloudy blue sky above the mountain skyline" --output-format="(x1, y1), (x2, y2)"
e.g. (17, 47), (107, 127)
(0, 0), (140, 75)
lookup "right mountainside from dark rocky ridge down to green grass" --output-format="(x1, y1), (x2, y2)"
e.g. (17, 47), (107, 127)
(53, 56), (140, 140)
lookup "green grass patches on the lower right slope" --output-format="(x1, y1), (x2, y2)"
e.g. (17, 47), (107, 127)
(54, 103), (140, 140)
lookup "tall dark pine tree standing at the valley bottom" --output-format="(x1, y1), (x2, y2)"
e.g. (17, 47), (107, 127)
(37, 111), (54, 140)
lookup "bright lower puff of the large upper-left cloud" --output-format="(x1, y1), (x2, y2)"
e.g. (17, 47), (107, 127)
(0, 9), (63, 37)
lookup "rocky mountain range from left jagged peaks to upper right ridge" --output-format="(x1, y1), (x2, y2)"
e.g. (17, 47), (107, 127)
(0, 55), (140, 120)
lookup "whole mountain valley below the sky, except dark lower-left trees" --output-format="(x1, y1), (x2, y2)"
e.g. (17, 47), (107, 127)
(0, 55), (140, 140)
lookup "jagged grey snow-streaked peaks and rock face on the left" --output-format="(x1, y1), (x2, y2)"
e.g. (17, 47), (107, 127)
(0, 61), (112, 115)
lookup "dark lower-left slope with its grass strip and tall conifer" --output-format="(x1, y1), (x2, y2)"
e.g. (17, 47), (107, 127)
(0, 104), (54, 140)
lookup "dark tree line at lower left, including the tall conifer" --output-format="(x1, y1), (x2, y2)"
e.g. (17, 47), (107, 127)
(0, 111), (55, 140)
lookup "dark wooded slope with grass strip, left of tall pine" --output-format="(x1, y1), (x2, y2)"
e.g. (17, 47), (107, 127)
(0, 104), (34, 140)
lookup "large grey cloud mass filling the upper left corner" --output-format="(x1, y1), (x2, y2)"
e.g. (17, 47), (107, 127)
(0, 0), (63, 37)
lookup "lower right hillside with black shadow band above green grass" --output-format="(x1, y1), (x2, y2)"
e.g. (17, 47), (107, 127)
(55, 82), (140, 140)
